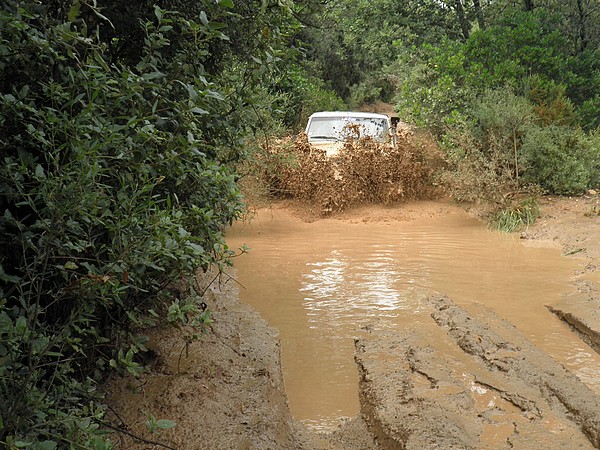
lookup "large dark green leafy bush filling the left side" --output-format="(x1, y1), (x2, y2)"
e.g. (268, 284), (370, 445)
(0, 2), (242, 449)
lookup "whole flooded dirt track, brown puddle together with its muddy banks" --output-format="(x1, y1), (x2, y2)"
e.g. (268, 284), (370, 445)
(104, 198), (600, 450)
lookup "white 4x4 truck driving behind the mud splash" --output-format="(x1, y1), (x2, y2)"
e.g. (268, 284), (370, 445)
(306, 111), (396, 157)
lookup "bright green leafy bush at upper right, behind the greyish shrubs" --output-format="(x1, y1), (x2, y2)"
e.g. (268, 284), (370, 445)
(384, 7), (600, 135)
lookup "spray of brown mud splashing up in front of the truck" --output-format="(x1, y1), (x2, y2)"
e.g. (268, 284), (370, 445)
(273, 132), (443, 215)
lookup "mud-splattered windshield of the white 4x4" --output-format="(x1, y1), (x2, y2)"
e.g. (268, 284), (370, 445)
(306, 117), (389, 142)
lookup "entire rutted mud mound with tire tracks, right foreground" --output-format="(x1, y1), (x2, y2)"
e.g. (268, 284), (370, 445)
(355, 297), (600, 449)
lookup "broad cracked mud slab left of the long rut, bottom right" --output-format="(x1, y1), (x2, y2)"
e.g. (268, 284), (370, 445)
(356, 314), (593, 449)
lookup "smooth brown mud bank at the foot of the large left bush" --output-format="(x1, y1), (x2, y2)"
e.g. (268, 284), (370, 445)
(107, 276), (311, 449)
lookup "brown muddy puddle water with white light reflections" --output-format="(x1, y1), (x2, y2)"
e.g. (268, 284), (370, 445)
(227, 202), (600, 430)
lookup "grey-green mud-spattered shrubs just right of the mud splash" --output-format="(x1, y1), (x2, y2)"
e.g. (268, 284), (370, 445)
(442, 84), (600, 209)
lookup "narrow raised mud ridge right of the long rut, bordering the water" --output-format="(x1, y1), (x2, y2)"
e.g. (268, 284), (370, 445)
(432, 298), (600, 447)
